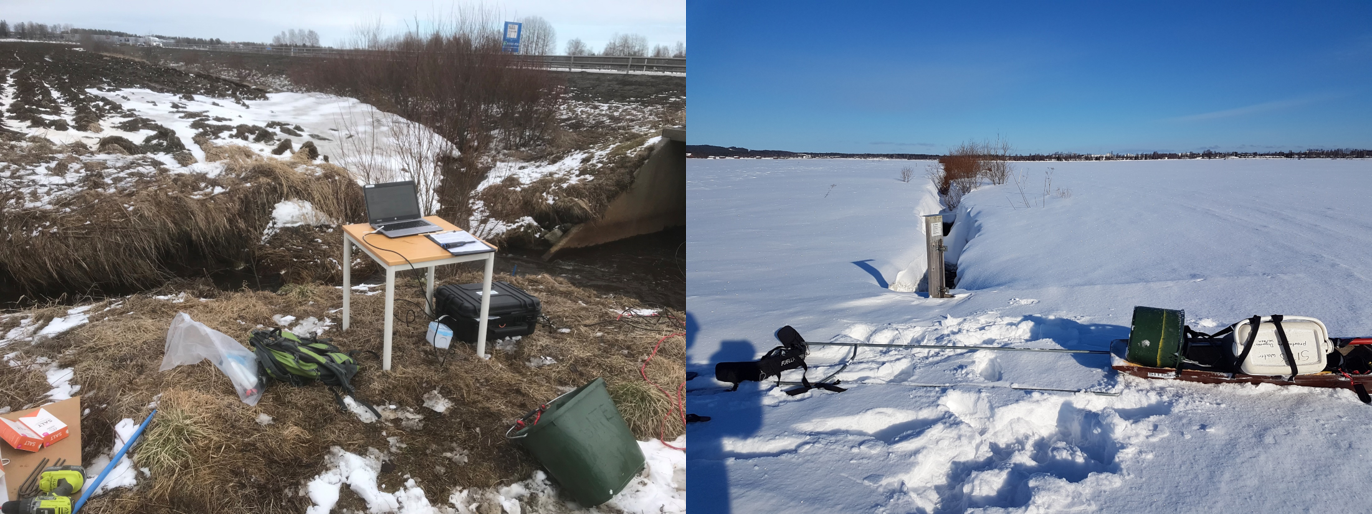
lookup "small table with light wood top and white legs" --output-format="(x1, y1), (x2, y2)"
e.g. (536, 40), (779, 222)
(343, 217), (495, 370)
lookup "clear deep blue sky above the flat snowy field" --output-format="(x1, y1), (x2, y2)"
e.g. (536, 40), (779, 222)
(686, 0), (1372, 154)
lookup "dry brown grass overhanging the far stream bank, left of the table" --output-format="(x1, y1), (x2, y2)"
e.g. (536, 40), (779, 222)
(0, 145), (364, 292)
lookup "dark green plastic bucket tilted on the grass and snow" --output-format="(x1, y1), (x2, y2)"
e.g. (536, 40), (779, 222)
(505, 378), (643, 507)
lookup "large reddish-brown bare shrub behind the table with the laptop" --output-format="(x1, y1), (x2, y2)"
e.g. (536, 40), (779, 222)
(292, 7), (561, 225)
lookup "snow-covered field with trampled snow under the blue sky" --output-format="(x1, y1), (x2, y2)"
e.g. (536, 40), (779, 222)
(687, 159), (1372, 513)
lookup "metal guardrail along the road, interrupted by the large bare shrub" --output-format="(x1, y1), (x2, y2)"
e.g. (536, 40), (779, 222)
(161, 45), (686, 74)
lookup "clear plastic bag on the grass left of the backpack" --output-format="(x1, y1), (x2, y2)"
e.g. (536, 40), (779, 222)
(158, 313), (262, 406)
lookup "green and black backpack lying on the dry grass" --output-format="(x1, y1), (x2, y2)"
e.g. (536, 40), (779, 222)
(248, 329), (381, 419)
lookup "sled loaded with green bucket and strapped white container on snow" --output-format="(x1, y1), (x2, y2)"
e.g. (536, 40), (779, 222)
(1111, 307), (1372, 403)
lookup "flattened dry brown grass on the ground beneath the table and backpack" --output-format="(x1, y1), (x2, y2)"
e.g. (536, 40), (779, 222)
(0, 267), (685, 514)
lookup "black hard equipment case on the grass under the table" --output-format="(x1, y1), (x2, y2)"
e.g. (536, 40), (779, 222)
(434, 282), (542, 343)
